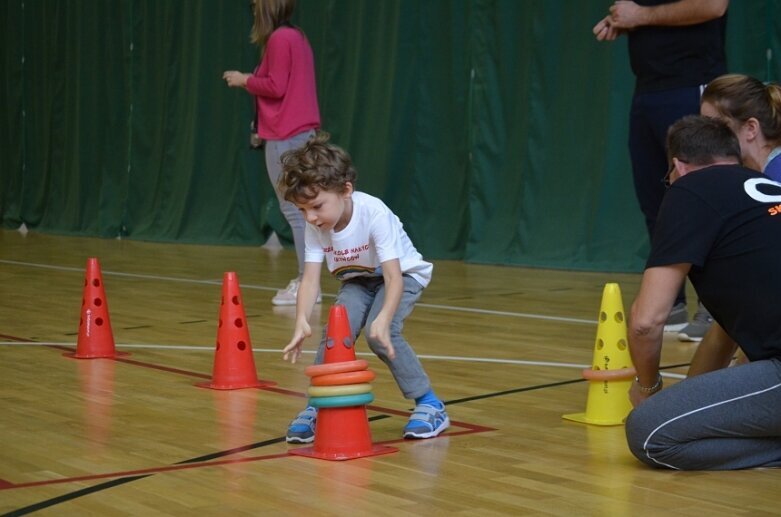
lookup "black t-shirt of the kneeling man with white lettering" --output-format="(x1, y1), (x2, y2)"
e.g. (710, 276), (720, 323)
(646, 165), (781, 360)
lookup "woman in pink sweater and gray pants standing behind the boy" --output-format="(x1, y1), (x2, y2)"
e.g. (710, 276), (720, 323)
(222, 0), (320, 305)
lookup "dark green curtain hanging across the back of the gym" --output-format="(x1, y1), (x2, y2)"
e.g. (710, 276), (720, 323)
(0, 0), (781, 271)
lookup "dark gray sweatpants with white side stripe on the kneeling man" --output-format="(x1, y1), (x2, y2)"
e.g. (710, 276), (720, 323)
(626, 359), (781, 470)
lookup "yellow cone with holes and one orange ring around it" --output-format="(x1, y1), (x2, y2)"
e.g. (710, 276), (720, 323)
(563, 284), (635, 425)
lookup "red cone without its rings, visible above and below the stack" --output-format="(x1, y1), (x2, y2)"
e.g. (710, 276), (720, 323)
(290, 305), (398, 461)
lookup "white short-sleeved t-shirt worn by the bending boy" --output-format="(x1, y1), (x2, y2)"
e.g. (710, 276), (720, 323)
(304, 192), (434, 287)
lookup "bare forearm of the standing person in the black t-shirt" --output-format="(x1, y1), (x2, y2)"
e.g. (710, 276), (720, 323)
(610, 0), (729, 30)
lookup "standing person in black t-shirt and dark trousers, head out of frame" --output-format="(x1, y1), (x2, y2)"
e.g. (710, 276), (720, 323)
(593, 0), (729, 341)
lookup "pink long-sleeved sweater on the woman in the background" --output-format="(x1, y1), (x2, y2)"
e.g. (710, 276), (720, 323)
(247, 27), (320, 140)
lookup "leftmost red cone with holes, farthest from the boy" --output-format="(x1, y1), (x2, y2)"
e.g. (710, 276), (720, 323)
(64, 258), (128, 359)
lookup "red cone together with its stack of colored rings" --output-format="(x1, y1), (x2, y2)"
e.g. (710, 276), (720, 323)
(290, 305), (398, 461)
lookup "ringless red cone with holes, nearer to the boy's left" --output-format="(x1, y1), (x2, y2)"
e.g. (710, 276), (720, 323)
(196, 272), (276, 390)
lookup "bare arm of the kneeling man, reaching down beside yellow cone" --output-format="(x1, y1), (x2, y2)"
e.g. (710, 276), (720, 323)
(627, 264), (691, 406)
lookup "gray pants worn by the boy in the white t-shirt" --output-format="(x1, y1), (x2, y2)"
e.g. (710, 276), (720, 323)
(315, 275), (431, 399)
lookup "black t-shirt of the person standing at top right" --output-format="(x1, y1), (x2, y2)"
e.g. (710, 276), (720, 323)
(628, 0), (727, 93)
